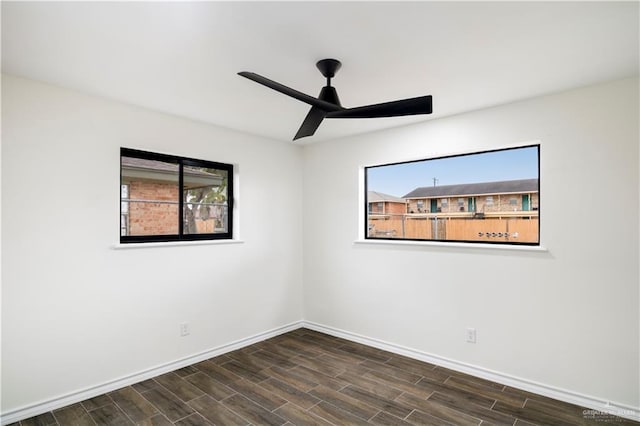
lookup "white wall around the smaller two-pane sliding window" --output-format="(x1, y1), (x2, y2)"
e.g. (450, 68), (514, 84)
(2, 76), (302, 413)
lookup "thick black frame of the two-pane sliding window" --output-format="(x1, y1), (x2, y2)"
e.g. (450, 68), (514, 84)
(118, 147), (234, 244)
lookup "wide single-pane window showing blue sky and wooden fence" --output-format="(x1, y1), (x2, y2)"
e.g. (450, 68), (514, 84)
(364, 145), (540, 245)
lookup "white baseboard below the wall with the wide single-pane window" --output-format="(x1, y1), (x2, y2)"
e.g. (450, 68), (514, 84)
(302, 321), (640, 421)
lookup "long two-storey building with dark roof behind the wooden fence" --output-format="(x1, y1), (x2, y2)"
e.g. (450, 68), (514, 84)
(403, 179), (539, 217)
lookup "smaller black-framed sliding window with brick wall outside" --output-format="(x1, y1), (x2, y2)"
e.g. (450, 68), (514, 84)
(120, 148), (233, 243)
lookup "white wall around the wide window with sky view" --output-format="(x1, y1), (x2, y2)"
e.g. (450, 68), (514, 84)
(304, 79), (640, 407)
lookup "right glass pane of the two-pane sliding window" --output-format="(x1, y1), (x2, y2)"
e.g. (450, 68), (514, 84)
(184, 166), (229, 234)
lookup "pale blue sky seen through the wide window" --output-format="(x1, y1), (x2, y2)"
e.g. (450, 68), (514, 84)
(366, 146), (538, 197)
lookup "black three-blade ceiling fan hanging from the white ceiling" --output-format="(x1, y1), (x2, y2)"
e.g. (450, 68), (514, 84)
(238, 59), (432, 140)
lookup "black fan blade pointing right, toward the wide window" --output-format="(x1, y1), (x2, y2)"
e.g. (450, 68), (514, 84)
(327, 95), (432, 118)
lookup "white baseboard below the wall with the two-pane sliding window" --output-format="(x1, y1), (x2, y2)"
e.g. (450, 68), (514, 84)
(0, 321), (303, 425)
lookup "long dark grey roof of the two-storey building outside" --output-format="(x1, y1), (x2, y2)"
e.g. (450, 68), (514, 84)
(403, 179), (538, 198)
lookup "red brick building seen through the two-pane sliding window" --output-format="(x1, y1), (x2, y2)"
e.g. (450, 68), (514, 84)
(120, 157), (223, 235)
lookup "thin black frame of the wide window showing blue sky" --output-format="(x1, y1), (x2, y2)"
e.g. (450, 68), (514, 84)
(363, 143), (542, 247)
